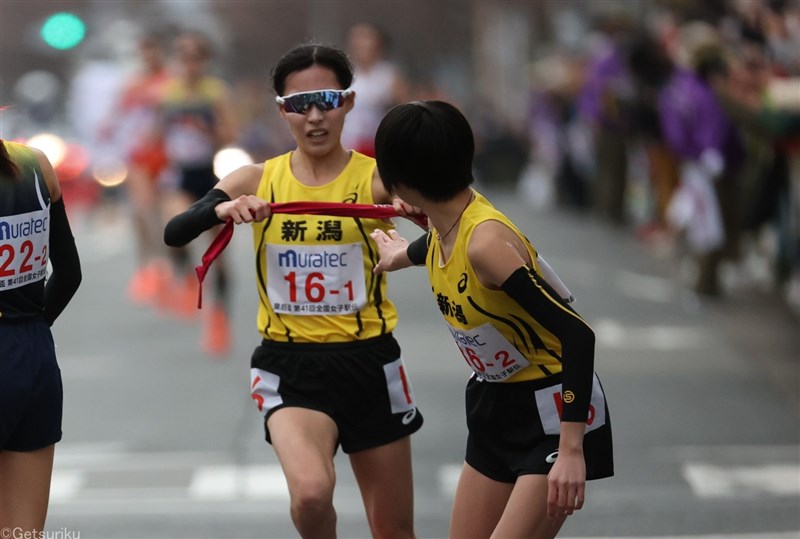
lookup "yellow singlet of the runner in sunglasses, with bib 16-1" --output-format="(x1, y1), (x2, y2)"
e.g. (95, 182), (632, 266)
(253, 152), (397, 342)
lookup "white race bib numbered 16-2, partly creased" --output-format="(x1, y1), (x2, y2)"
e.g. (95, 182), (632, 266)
(448, 324), (530, 382)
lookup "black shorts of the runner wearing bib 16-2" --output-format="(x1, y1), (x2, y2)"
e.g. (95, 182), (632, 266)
(465, 375), (614, 483)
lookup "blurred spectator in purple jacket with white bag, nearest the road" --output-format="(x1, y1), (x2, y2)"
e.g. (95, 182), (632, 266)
(629, 32), (743, 296)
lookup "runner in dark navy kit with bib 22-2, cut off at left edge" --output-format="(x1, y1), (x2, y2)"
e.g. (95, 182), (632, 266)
(0, 140), (81, 534)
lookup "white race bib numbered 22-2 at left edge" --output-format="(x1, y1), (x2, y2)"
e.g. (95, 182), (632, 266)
(0, 210), (50, 290)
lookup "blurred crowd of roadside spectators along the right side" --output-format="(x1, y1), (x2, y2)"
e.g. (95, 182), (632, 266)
(519, 0), (800, 313)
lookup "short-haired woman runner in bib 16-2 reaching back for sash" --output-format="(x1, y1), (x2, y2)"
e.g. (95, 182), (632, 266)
(372, 101), (614, 539)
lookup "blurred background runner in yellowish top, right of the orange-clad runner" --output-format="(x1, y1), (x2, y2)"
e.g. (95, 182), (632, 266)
(161, 31), (236, 356)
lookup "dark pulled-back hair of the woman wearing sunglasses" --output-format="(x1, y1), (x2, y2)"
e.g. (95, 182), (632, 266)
(271, 43), (353, 95)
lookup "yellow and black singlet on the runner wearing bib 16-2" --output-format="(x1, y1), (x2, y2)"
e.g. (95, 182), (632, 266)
(426, 192), (562, 382)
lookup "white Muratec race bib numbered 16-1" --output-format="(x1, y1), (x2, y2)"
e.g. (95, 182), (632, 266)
(265, 243), (367, 316)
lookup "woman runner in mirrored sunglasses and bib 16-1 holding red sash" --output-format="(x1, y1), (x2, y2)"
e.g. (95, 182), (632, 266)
(165, 44), (422, 538)
